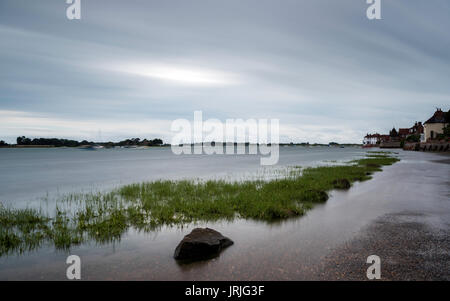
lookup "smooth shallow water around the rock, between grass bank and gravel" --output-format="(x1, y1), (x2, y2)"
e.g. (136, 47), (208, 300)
(0, 152), (450, 280)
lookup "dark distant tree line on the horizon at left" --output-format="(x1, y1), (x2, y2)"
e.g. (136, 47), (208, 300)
(14, 136), (163, 147)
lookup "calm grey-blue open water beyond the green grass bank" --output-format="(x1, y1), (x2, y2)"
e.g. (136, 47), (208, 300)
(0, 147), (364, 205)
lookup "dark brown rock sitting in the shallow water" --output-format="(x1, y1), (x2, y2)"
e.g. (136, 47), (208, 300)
(174, 228), (233, 260)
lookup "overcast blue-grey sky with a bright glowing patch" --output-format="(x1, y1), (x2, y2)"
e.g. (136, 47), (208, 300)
(0, 0), (450, 143)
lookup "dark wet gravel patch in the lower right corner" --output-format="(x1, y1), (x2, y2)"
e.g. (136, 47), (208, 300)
(320, 212), (450, 281)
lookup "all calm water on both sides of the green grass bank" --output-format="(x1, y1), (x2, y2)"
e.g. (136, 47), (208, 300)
(0, 147), (450, 280)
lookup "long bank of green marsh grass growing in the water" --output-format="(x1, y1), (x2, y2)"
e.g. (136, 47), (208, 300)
(0, 153), (398, 256)
